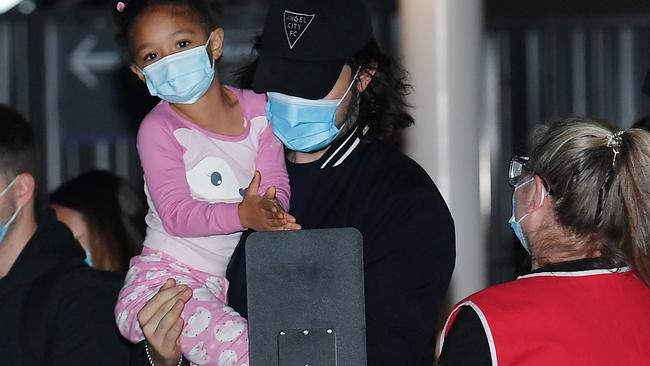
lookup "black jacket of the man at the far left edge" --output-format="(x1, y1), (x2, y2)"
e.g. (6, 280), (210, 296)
(0, 210), (130, 366)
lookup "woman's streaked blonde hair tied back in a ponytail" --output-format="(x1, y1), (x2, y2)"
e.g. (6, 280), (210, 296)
(530, 117), (650, 286)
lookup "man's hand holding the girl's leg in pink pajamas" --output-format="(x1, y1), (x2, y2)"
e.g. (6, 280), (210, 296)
(138, 278), (192, 366)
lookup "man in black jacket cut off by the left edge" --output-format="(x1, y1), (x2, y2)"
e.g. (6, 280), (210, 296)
(0, 105), (129, 366)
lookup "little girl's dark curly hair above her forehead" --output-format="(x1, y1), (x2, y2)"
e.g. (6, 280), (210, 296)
(112, 0), (223, 58)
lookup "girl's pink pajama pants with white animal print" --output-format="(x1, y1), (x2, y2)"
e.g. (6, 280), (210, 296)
(115, 248), (248, 366)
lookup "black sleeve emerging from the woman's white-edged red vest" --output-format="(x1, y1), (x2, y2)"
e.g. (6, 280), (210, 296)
(440, 306), (492, 366)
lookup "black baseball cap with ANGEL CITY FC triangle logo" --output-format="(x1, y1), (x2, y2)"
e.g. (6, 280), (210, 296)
(253, 0), (373, 99)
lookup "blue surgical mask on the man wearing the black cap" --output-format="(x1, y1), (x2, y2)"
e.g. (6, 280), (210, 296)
(266, 69), (360, 152)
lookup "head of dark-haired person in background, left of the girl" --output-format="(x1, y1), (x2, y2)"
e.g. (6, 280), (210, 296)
(50, 170), (147, 276)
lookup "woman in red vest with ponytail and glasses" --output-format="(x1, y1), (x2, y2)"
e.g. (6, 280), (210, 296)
(440, 118), (650, 366)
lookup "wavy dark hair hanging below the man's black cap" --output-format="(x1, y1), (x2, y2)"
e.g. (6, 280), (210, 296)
(236, 35), (413, 142)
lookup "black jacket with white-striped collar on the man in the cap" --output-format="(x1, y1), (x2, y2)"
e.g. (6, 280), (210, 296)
(228, 126), (455, 366)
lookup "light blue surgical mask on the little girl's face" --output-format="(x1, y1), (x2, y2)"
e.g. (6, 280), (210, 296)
(141, 35), (214, 104)
